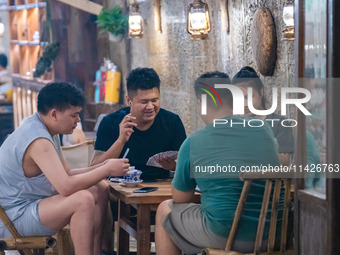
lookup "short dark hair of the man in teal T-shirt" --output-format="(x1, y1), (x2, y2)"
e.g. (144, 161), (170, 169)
(194, 71), (233, 107)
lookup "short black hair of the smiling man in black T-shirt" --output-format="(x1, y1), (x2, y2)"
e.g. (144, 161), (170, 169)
(126, 67), (161, 94)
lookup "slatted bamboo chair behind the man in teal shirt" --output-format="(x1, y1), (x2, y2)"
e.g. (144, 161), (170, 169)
(202, 172), (294, 255)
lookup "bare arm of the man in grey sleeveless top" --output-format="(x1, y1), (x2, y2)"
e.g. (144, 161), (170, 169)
(24, 139), (130, 196)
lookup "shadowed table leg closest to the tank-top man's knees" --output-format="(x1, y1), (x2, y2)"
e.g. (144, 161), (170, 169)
(117, 200), (130, 255)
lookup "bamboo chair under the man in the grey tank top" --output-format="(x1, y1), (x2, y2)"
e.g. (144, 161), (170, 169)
(0, 206), (57, 255)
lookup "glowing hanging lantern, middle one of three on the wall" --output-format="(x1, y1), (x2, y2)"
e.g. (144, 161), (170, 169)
(187, 0), (211, 40)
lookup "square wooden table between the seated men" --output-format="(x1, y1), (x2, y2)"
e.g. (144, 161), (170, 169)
(110, 180), (200, 255)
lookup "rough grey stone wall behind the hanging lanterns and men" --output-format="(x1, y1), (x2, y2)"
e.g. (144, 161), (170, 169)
(110, 0), (294, 133)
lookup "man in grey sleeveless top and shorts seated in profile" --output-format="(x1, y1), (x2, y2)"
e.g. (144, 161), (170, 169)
(0, 83), (130, 255)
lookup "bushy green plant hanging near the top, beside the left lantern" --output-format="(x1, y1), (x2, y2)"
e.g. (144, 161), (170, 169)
(96, 5), (129, 36)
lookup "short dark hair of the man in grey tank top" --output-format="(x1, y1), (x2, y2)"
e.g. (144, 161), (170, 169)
(38, 82), (86, 115)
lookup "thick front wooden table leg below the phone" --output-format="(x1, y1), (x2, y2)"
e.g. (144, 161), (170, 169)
(137, 204), (151, 255)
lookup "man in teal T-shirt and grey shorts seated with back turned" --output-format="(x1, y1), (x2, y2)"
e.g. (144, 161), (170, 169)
(156, 72), (279, 255)
